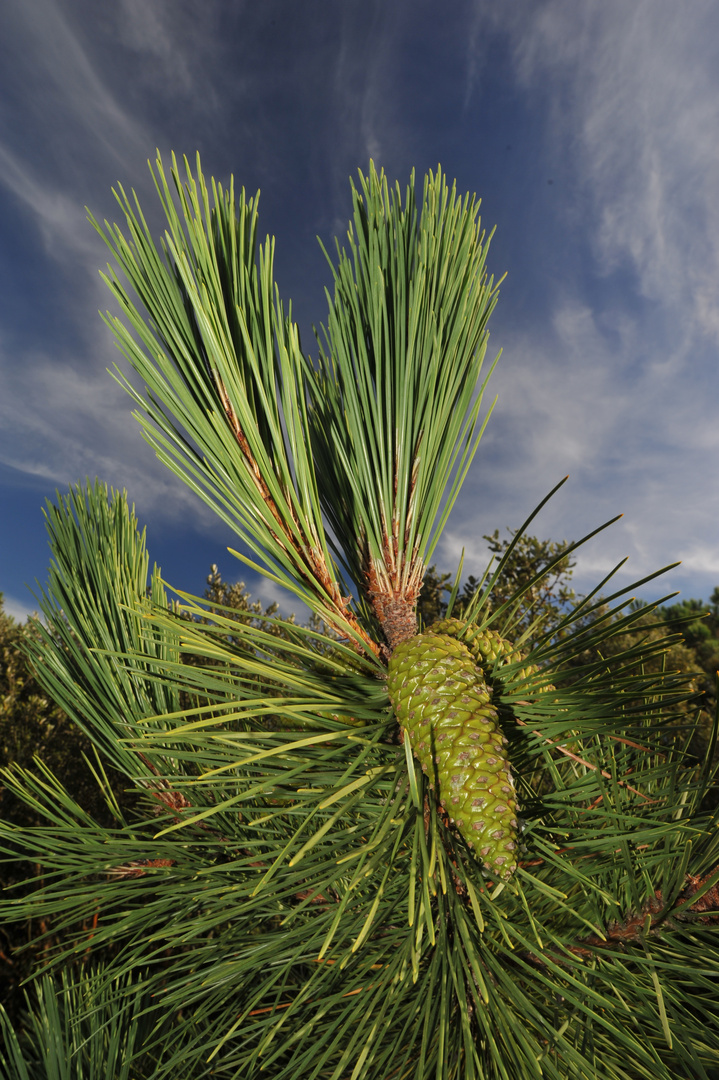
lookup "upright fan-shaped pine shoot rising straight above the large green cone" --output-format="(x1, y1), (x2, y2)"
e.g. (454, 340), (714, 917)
(307, 162), (497, 651)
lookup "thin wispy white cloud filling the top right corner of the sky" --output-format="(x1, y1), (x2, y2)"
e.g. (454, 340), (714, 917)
(499, 0), (719, 349)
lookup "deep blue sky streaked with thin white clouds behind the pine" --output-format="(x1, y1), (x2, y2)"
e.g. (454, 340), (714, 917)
(0, 0), (719, 617)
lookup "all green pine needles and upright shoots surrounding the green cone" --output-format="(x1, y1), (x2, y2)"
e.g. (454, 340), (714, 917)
(0, 162), (719, 1080)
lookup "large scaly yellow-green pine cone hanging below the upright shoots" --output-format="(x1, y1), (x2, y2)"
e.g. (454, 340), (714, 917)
(388, 620), (517, 879)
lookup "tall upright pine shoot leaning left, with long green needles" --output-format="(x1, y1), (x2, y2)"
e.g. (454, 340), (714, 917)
(91, 156), (379, 639)
